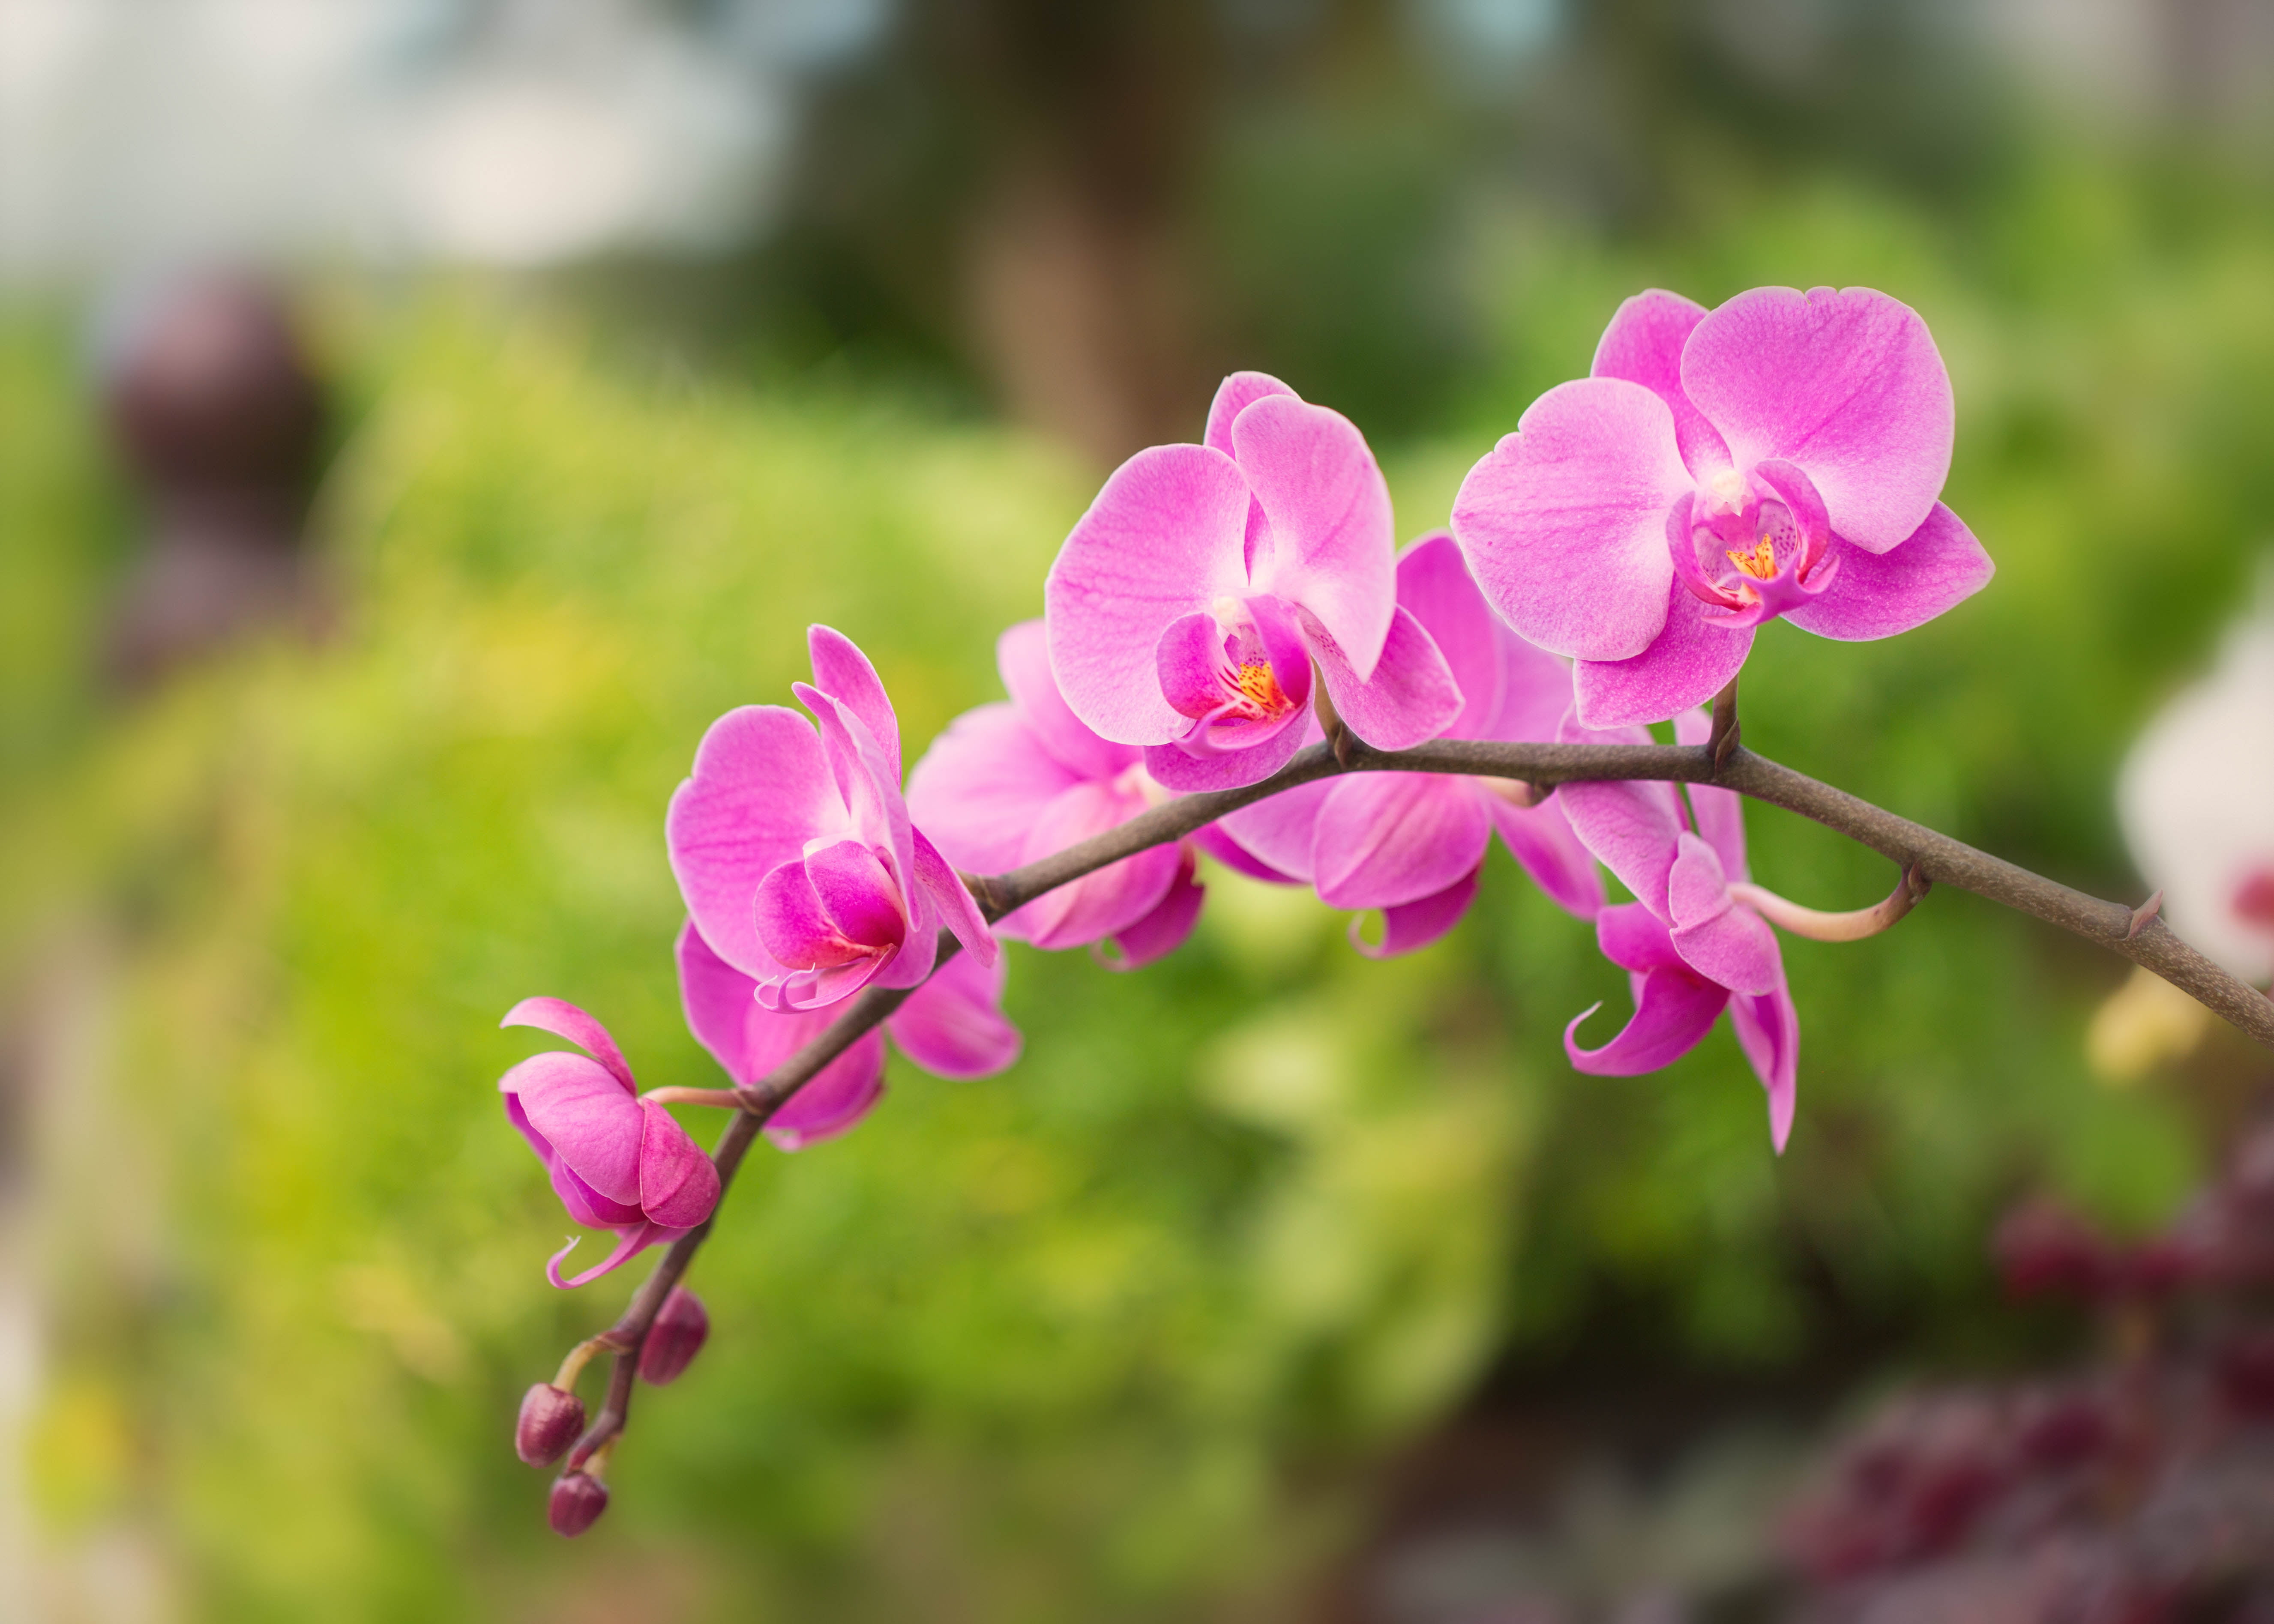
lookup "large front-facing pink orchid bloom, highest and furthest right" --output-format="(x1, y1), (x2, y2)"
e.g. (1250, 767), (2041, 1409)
(1453, 287), (1994, 728)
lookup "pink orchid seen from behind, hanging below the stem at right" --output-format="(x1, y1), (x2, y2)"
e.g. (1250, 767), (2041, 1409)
(1555, 710), (1806, 1153)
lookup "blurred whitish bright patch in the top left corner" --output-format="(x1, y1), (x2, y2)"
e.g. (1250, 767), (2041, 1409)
(0, 0), (889, 287)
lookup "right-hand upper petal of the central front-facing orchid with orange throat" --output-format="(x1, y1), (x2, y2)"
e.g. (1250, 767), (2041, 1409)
(1232, 396), (1396, 678)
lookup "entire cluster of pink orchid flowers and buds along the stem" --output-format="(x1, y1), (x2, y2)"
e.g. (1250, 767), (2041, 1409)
(500, 289), (1992, 1533)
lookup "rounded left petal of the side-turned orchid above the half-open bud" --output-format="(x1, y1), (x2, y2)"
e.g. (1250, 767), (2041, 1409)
(664, 705), (846, 978)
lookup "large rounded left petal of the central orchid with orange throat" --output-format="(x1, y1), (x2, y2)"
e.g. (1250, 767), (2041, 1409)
(1042, 446), (1249, 744)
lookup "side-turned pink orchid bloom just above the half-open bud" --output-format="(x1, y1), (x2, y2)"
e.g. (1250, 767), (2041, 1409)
(664, 625), (996, 1010)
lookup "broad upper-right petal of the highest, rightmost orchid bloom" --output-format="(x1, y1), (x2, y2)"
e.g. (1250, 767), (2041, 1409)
(1683, 287), (1958, 553)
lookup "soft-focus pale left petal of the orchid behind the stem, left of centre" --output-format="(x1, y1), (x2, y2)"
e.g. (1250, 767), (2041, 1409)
(907, 705), (1078, 873)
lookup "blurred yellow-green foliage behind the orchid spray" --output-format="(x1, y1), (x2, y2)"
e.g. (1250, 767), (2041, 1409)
(0, 133), (2274, 1619)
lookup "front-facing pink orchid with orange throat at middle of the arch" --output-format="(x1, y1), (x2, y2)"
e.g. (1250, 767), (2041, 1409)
(1044, 373), (1462, 789)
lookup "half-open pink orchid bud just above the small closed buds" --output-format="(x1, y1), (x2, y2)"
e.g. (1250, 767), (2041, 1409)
(498, 999), (719, 1287)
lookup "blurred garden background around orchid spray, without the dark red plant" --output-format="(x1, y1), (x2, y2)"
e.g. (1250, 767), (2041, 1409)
(0, 0), (2274, 1624)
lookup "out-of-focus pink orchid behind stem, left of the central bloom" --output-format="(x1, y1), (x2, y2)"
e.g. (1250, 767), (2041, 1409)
(907, 621), (1287, 969)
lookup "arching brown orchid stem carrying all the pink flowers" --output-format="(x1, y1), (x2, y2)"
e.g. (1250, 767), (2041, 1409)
(554, 730), (2274, 1465)
